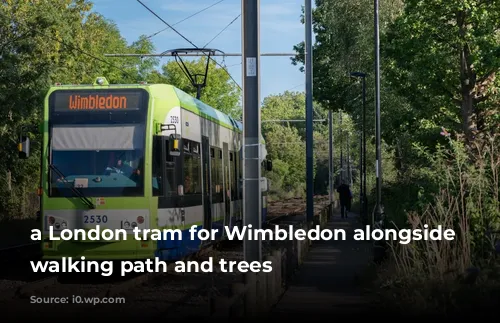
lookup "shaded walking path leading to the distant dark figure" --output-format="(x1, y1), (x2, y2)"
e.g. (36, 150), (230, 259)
(271, 213), (373, 318)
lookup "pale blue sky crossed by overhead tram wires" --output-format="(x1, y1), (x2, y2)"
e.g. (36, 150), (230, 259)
(92, 0), (305, 101)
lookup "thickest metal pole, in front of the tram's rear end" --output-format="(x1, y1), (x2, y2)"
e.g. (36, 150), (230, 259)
(241, 0), (262, 262)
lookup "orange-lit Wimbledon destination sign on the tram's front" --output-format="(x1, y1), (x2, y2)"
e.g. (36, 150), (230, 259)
(50, 89), (145, 112)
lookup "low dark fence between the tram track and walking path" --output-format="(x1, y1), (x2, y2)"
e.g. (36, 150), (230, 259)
(209, 205), (333, 317)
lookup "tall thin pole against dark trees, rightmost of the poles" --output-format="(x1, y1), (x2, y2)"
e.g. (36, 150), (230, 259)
(374, 0), (384, 225)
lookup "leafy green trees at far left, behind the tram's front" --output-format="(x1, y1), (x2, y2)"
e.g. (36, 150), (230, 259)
(0, 0), (154, 217)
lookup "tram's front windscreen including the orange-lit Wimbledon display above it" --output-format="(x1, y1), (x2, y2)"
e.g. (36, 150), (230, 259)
(48, 89), (147, 197)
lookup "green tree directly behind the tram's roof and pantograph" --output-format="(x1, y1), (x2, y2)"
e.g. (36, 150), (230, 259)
(150, 57), (242, 120)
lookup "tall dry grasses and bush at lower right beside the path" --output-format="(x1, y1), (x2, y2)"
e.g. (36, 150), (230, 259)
(376, 136), (500, 313)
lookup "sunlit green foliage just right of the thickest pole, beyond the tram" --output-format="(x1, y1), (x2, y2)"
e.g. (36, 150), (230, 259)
(261, 91), (328, 198)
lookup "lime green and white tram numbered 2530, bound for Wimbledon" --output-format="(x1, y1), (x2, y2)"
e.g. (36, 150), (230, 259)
(19, 77), (272, 261)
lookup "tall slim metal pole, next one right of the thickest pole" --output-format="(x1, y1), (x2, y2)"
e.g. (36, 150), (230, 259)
(305, 0), (314, 222)
